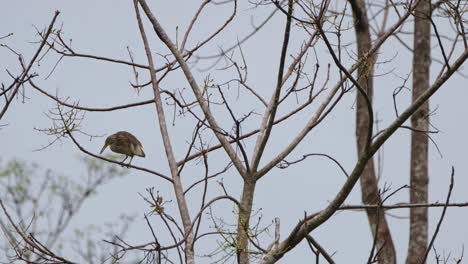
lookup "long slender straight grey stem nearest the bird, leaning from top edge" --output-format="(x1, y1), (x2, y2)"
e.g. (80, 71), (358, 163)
(133, 0), (195, 263)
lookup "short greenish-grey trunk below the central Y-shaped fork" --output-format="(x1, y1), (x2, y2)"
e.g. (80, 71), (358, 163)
(236, 180), (255, 264)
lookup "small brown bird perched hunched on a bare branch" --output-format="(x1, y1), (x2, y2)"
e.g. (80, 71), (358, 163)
(100, 131), (145, 165)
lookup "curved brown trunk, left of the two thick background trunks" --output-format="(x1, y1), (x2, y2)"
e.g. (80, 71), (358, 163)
(350, 0), (396, 263)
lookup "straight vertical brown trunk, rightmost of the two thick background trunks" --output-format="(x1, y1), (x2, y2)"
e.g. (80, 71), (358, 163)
(406, 1), (431, 264)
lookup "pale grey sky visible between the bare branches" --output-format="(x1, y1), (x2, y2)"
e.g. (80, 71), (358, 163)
(0, 0), (468, 263)
